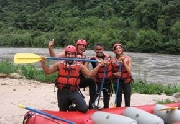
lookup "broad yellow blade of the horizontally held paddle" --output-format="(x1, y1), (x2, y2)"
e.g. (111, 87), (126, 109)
(14, 53), (41, 63)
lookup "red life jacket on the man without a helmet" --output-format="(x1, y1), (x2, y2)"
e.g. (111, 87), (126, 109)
(93, 54), (112, 83)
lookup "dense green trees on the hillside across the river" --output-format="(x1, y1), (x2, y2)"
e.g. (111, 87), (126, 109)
(0, 0), (180, 54)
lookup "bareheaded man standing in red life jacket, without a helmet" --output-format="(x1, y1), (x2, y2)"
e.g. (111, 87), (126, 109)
(91, 43), (112, 108)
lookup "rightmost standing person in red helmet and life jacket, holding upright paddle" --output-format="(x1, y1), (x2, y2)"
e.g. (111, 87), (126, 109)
(112, 43), (133, 107)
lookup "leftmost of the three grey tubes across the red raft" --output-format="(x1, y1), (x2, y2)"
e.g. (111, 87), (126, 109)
(91, 111), (137, 124)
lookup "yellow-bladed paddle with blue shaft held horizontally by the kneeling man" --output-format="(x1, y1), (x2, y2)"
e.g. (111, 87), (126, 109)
(14, 53), (98, 63)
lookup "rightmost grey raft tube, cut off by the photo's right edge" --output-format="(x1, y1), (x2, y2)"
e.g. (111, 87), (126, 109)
(154, 104), (180, 124)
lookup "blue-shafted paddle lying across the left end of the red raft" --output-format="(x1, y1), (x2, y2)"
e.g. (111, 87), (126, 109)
(19, 104), (76, 124)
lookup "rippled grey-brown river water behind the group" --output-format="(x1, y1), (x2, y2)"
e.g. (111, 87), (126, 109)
(0, 48), (180, 86)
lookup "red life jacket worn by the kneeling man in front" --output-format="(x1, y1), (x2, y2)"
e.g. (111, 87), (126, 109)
(57, 61), (80, 90)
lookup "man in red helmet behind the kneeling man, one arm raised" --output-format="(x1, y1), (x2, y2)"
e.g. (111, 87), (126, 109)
(49, 39), (96, 109)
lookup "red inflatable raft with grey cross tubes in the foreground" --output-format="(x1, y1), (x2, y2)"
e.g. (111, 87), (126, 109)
(23, 102), (180, 124)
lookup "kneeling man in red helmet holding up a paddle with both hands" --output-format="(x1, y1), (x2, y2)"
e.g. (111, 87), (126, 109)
(41, 45), (103, 113)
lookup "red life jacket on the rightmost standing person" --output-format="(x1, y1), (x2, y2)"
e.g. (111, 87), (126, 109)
(112, 56), (133, 83)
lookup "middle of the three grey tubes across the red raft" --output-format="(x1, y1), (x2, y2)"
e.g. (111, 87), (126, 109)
(123, 107), (164, 124)
